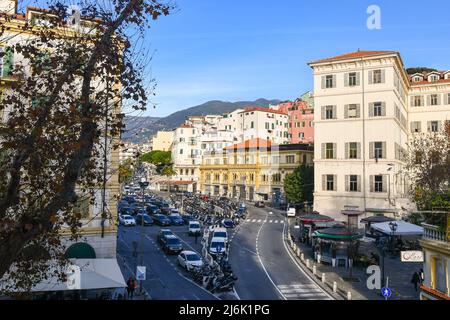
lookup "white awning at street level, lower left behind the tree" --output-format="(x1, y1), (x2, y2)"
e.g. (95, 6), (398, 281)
(3, 259), (127, 292)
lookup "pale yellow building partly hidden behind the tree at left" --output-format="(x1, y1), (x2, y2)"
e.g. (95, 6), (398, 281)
(0, 0), (125, 298)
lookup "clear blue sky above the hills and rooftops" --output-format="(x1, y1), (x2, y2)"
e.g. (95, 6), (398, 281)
(145, 0), (450, 116)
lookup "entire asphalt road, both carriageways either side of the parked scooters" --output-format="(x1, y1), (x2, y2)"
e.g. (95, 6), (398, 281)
(117, 195), (330, 300)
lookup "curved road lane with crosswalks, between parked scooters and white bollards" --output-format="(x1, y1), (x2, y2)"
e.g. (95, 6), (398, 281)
(230, 205), (330, 300)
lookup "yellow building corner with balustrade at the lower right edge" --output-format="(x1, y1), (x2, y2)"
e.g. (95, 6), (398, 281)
(420, 212), (450, 300)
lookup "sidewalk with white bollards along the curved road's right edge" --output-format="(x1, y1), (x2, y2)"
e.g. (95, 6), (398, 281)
(289, 223), (422, 300)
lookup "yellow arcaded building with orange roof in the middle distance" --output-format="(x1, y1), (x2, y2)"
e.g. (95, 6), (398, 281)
(200, 138), (314, 202)
